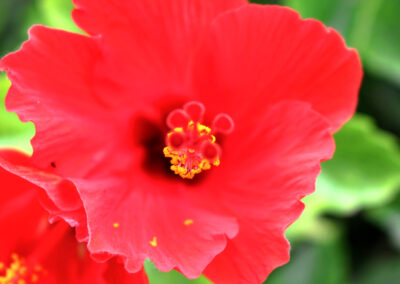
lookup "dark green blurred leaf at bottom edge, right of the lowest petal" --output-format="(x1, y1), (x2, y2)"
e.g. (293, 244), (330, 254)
(265, 238), (348, 284)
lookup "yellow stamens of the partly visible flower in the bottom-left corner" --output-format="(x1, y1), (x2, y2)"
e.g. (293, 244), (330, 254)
(0, 253), (46, 284)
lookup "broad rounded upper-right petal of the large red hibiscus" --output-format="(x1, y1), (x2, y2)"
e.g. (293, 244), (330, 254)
(193, 5), (362, 130)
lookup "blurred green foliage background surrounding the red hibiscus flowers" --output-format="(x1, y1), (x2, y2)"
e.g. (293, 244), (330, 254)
(0, 0), (400, 284)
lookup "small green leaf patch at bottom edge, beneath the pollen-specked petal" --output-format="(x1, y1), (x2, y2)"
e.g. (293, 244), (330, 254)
(144, 260), (211, 284)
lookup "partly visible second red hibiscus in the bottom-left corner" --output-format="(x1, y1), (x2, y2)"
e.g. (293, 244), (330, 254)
(0, 150), (148, 284)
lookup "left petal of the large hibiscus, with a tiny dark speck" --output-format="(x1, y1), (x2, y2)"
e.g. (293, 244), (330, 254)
(0, 26), (119, 177)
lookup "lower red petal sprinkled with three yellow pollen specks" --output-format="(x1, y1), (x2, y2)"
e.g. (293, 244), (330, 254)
(75, 175), (238, 278)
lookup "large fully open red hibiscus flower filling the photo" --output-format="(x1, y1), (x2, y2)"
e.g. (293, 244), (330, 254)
(0, 0), (362, 283)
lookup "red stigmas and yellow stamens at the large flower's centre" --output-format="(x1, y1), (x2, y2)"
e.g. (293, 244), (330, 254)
(163, 102), (234, 179)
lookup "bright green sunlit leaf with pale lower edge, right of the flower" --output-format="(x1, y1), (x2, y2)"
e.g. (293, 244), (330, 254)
(287, 115), (400, 240)
